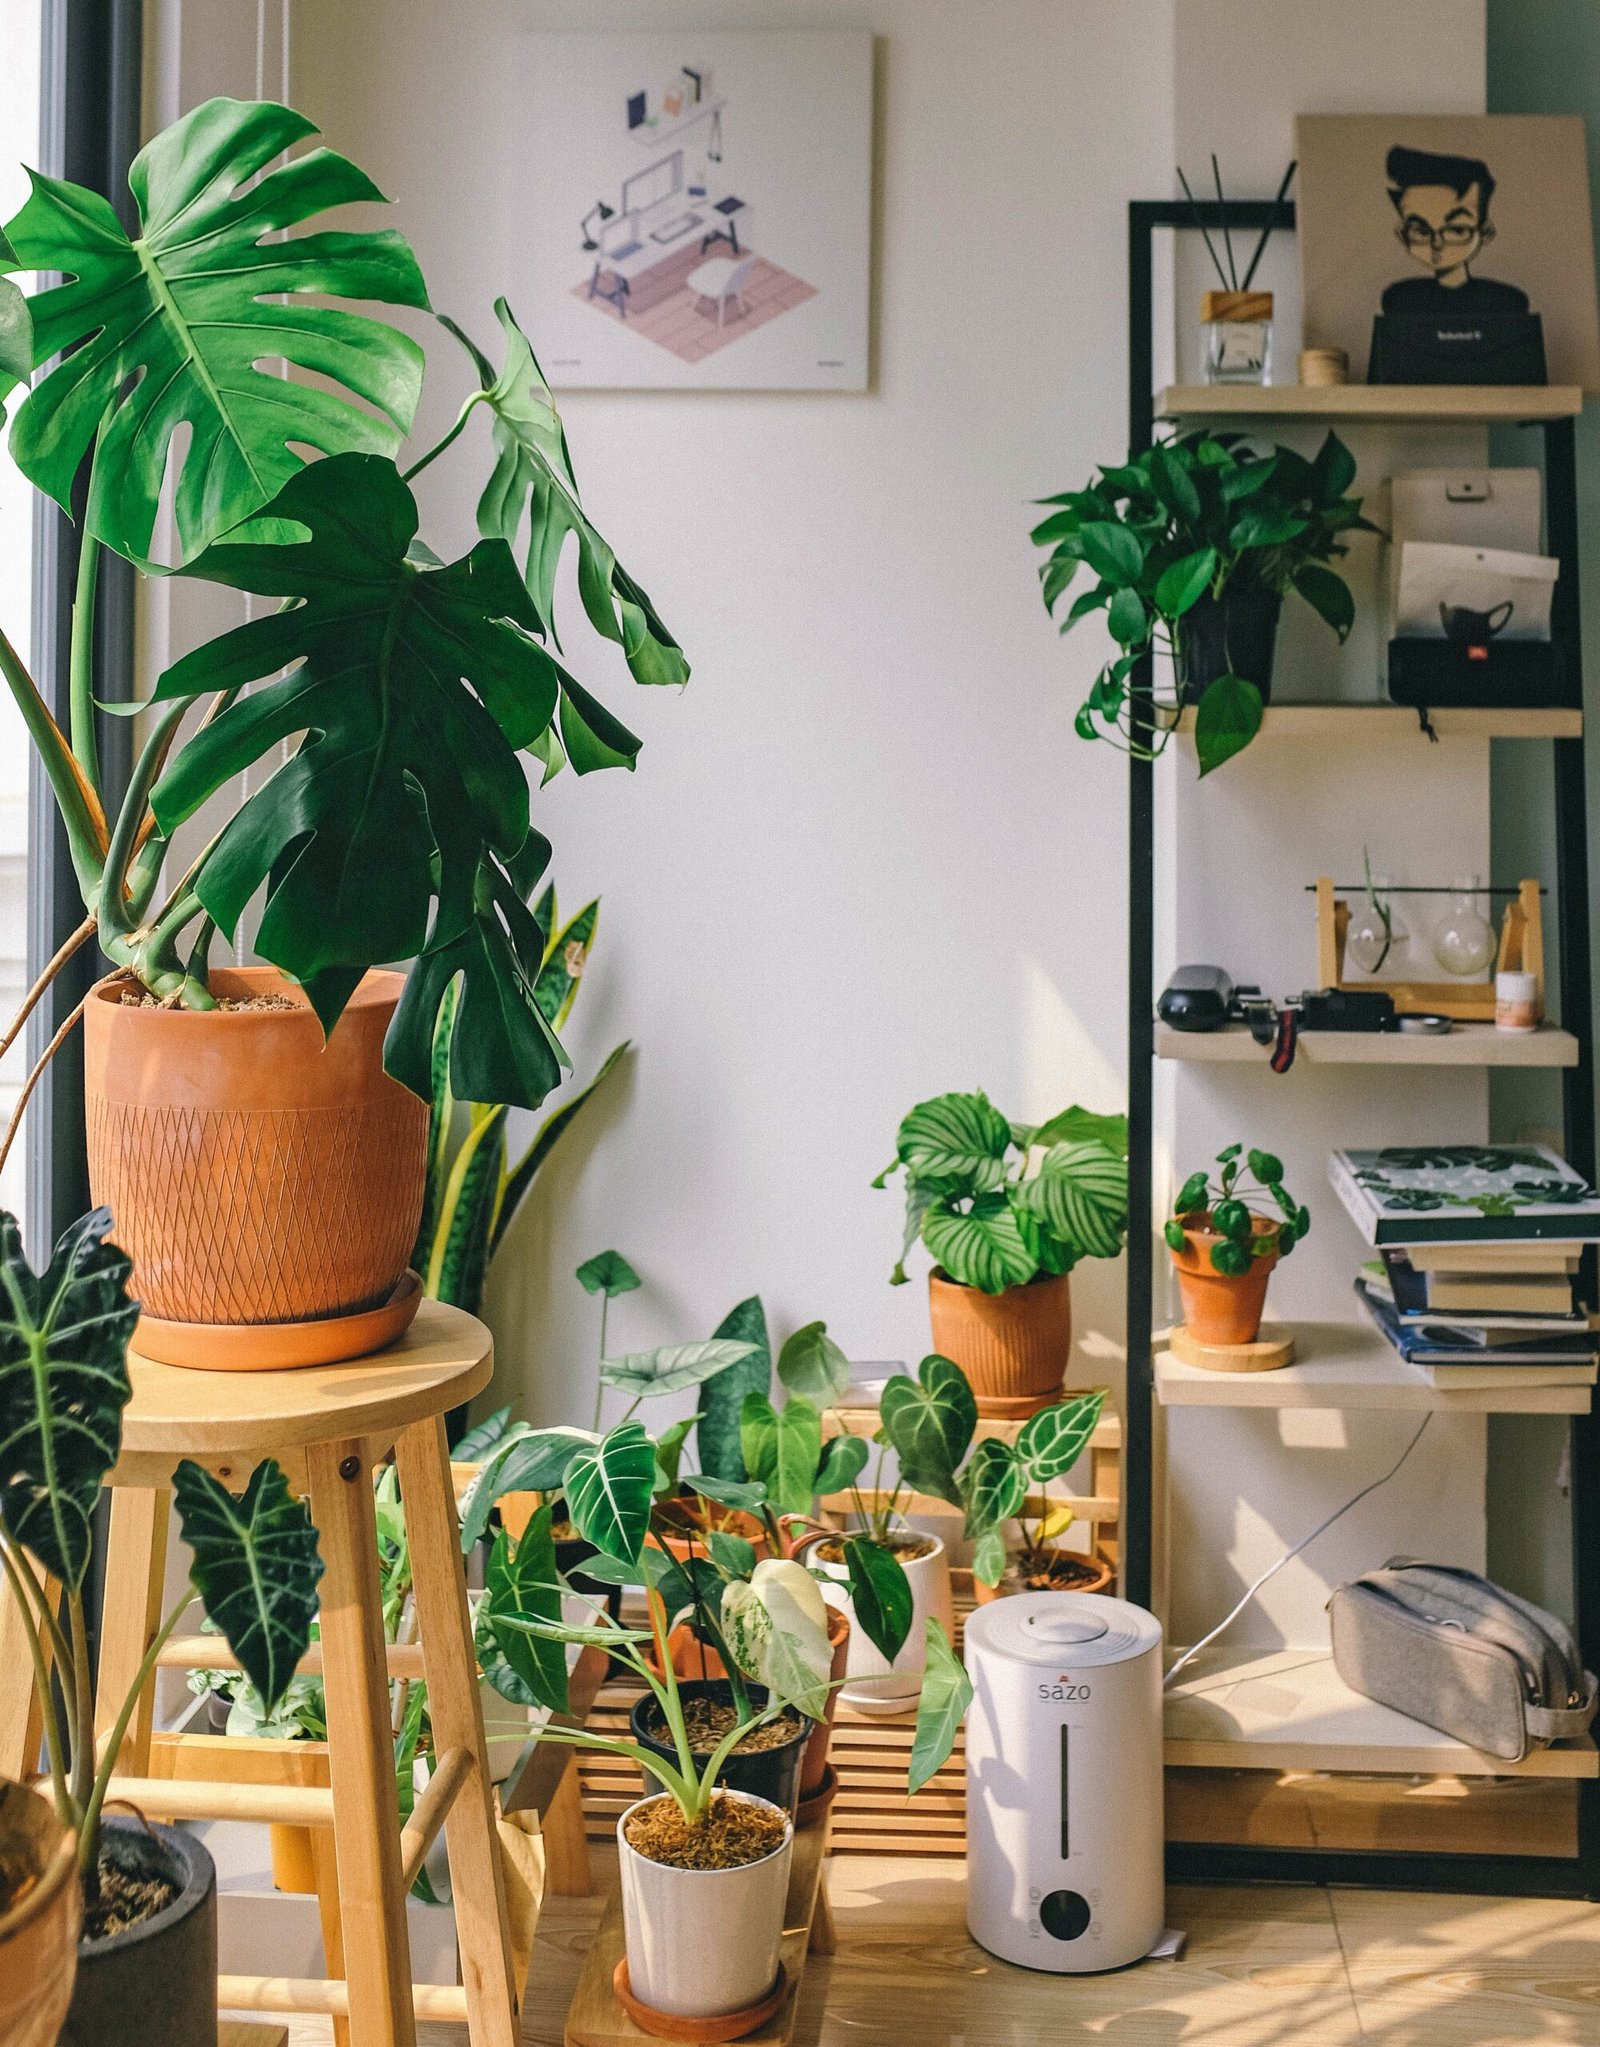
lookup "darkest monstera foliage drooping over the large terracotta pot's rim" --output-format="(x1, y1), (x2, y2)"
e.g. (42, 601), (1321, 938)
(151, 454), (563, 1107)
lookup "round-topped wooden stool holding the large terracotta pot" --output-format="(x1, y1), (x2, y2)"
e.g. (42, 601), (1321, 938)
(25, 1302), (522, 2047)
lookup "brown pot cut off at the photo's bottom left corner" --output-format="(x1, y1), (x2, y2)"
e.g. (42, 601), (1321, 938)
(0, 1783), (84, 2047)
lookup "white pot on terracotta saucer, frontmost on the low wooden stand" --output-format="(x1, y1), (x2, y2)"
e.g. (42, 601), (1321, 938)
(616, 1791), (794, 2018)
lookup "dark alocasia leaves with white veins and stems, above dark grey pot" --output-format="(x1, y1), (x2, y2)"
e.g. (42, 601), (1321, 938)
(0, 1210), (321, 1898)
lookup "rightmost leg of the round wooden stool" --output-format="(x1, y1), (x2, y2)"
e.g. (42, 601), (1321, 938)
(395, 1417), (522, 2047)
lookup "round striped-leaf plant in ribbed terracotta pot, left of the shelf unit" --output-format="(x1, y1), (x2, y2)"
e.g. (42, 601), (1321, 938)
(874, 1095), (1127, 1419)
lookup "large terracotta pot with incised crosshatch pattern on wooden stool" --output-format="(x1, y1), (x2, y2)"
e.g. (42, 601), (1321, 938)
(84, 966), (428, 1355)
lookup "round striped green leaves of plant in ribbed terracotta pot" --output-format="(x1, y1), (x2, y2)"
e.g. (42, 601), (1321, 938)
(874, 1095), (1127, 1294)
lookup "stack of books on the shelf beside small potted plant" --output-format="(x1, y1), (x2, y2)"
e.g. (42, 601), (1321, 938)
(1328, 1144), (1600, 1388)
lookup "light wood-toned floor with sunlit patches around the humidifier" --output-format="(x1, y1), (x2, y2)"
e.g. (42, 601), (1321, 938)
(270, 1855), (1600, 2047)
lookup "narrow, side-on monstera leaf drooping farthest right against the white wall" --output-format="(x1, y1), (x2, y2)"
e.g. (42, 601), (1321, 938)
(444, 299), (690, 691)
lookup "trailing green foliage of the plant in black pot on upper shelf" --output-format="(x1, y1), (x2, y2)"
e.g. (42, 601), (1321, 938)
(1033, 432), (1377, 774)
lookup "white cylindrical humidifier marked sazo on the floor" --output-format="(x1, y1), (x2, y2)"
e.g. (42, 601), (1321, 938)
(966, 1593), (1166, 1975)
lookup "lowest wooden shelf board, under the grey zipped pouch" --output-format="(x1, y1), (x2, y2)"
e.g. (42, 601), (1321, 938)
(1166, 1648), (1600, 1777)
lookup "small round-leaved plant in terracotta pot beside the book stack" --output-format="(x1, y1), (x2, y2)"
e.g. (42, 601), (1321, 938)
(1164, 1144), (1312, 1349)
